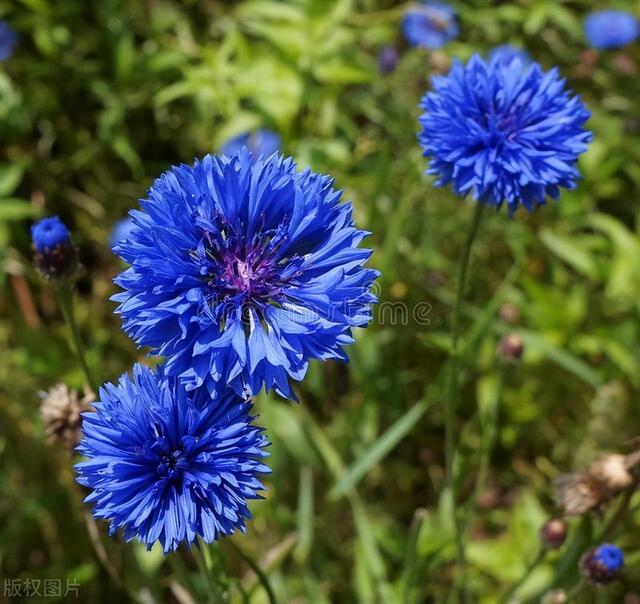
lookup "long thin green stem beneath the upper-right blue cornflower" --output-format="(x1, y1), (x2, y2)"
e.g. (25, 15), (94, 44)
(444, 202), (484, 601)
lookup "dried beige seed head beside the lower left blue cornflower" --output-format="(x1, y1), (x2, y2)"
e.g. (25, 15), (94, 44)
(40, 384), (96, 449)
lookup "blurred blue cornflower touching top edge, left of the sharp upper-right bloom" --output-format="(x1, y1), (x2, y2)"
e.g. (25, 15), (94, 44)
(402, 1), (459, 49)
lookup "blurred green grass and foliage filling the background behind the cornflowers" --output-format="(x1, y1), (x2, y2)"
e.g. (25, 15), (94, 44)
(0, 0), (640, 604)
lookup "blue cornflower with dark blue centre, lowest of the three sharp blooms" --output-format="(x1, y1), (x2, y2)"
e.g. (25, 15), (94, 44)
(75, 365), (270, 553)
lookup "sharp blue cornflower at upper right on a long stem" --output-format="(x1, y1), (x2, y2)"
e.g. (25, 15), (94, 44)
(419, 55), (591, 212)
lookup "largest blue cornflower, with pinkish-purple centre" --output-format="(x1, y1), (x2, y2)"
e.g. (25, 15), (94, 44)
(113, 148), (377, 399)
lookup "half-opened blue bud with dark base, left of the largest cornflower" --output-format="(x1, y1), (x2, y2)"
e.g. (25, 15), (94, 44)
(31, 216), (78, 279)
